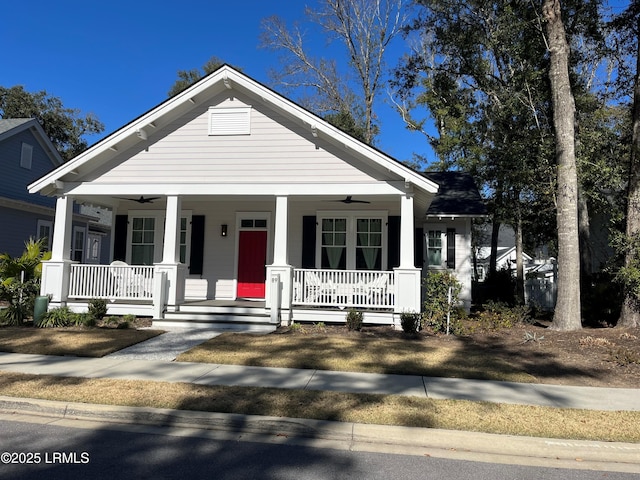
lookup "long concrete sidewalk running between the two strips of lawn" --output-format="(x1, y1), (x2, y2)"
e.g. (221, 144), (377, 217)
(0, 348), (640, 411)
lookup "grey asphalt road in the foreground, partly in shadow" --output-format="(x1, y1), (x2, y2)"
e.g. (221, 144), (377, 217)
(0, 421), (638, 480)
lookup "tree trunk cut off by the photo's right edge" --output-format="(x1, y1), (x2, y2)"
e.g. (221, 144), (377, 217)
(617, 15), (640, 327)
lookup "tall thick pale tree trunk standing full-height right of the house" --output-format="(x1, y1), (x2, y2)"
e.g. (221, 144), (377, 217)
(542, 0), (582, 330)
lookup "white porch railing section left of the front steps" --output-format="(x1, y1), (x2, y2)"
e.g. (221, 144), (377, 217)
(69, 264), (153, 300)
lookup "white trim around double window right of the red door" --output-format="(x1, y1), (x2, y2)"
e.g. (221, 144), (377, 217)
(316, 210), (389, 271)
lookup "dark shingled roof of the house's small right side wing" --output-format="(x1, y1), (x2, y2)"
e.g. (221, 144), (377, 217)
(423, 172), (487, 217)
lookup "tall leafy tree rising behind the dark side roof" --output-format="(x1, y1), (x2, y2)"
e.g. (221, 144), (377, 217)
(395, 0), (553, 301)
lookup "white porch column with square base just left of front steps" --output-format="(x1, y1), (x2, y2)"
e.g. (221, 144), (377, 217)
(155, 195), (187, 311)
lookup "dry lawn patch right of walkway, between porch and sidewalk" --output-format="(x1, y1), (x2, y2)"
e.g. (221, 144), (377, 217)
(176, 333), (535, 382)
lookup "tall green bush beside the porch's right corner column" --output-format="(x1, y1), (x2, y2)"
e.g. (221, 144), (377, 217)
(423, 271), (462, 332)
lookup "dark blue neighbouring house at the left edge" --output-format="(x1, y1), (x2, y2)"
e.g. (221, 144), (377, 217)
(0, 118), (108, 261)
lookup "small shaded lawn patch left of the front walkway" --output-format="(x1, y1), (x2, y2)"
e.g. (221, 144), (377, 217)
(0, 327), (162, 357)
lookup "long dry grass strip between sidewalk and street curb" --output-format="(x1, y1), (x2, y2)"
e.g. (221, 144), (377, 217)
(0, 372), (640, 442)
